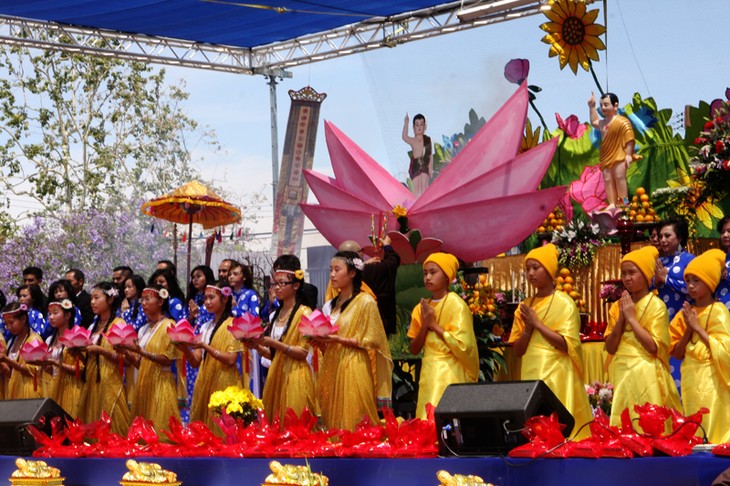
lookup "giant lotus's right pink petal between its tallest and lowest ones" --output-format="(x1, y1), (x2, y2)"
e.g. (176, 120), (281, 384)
(410, 137), (559, 215)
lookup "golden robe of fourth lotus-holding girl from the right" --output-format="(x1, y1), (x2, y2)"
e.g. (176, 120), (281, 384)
(132, 319), (180, 435)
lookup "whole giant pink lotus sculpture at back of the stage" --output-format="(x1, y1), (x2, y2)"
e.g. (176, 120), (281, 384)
(300, 83), (565, 262)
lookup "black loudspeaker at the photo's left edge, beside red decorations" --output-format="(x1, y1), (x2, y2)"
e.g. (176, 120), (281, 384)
(0, 398), (71, 456)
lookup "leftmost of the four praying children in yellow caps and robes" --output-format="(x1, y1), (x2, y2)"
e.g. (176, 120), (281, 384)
(408, 252), (479, 419)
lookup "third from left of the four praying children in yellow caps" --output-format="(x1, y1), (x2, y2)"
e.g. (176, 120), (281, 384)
(606, 246), (680, 425)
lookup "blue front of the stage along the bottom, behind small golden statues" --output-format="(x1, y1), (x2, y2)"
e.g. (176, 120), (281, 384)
(0, 453), (730, 486)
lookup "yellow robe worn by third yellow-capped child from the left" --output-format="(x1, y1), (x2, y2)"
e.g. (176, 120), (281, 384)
(605, 293), (681, 425)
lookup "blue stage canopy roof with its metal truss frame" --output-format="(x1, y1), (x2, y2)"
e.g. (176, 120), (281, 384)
(0, 0), (544, 75)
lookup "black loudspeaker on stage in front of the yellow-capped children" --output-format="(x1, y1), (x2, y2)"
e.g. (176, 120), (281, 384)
(436, 380), (575, 456)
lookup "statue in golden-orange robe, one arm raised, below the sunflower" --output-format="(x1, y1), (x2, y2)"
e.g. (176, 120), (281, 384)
(588, 93), (642, 210)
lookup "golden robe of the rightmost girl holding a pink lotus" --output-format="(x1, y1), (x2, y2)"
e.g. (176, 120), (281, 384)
(318, 292), (393, 430)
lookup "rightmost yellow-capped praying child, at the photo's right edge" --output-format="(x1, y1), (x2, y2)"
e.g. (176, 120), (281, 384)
(669, 249), (730, 444)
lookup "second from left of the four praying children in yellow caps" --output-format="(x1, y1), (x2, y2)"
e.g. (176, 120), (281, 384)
(509, 244), (593, 439)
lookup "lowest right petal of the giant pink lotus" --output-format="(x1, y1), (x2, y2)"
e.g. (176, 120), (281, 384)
(409, 186), (566, 262)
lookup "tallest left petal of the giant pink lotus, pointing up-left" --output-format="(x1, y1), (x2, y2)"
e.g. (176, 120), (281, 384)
(324, 121), (415, 208)
